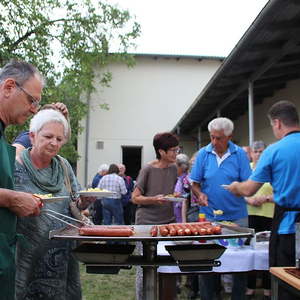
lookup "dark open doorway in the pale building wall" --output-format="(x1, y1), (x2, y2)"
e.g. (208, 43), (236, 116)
(122, 146), (143, 180)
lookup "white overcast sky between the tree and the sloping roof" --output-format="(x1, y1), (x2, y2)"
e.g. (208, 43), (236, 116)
(108, 0), (268, 56)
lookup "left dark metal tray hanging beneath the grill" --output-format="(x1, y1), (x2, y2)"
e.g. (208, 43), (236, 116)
(72, 243), (135, 263)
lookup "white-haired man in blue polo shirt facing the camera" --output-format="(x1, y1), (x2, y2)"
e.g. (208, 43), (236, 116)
(190, 118), (251, 300)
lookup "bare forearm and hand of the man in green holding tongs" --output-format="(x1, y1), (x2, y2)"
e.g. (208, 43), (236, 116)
(0, 189), (41, 217)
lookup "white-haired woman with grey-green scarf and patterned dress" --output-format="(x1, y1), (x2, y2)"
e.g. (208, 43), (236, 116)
(14, 109), (95, 300)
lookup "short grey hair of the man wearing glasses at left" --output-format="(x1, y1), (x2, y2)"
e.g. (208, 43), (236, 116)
(0, 59), (45, 86)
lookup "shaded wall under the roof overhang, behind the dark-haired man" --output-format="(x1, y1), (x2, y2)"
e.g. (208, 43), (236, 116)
(234, 80), (300, 145)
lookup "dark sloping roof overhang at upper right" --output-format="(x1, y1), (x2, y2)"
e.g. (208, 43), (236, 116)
(173, 0), (300, 135)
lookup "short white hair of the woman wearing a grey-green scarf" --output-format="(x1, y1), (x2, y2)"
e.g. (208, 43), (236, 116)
(29, 109), (69, 140)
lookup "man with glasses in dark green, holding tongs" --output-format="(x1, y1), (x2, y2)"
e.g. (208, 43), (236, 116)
(0, 60), (43, 300)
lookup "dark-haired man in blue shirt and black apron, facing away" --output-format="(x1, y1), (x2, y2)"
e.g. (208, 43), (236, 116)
(227, 101), (300, 299)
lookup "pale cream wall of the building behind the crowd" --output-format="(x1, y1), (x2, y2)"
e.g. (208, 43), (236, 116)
(77, 57), (221, 185)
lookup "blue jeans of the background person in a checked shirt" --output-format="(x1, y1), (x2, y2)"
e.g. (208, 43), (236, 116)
(102, 198), (124, 225)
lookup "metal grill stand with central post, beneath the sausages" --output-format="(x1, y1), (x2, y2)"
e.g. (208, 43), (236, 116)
(49, 224), (254, 300)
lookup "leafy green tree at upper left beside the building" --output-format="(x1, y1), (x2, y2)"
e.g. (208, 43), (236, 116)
(0, 0), (140, 163)
